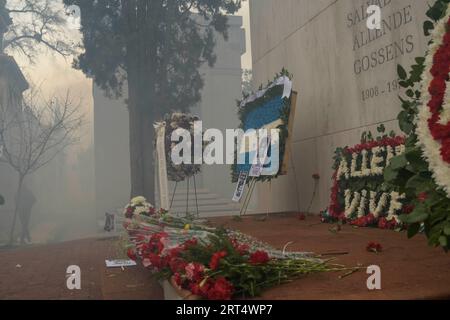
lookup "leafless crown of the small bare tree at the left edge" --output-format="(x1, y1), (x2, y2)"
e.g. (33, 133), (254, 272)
(0, 90), (84, 176)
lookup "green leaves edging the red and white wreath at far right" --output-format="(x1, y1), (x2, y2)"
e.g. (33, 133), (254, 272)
(385, 0), (450, 251)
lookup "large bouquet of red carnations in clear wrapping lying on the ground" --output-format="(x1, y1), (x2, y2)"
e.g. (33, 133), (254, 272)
(121, 196), (354, 300)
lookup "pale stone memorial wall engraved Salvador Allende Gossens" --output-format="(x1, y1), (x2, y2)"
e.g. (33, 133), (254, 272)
(250, 0), (429, 213)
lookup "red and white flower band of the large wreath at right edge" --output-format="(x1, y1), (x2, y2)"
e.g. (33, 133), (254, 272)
(417, 8), (450, 197)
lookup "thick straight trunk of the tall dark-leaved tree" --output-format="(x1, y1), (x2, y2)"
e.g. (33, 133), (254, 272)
(123, 0), (156, 204)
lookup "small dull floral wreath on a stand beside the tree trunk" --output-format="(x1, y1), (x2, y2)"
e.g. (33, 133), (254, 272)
(158, 112), (201, 182)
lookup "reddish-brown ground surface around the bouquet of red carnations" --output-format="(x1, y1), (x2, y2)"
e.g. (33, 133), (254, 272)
(0, 215), (450, 300)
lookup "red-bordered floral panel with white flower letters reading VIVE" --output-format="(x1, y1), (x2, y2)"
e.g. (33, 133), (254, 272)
(329, 136), (405, 228)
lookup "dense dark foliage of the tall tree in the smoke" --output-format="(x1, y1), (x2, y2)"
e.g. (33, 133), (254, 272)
(64, 0), (241, 112)
